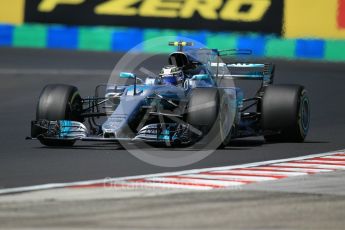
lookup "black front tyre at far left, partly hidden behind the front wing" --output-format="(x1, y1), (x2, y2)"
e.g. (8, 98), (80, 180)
(36, 84), (83, 146)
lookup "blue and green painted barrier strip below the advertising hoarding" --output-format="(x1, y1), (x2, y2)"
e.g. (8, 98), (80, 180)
(0, 24), (345, 61)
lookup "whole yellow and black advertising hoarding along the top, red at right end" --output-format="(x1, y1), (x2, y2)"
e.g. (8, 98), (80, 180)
(0, 0), (345, 39)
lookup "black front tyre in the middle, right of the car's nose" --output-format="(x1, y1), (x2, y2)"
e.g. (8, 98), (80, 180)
(187, 88), (227, 149)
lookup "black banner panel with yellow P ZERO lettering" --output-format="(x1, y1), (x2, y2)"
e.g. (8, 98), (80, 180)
(1, 0), (284, 35)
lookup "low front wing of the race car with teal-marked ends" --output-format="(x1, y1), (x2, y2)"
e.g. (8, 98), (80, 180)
(27, 120), (202, 145)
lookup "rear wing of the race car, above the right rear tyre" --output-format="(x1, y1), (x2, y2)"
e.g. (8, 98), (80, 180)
(211, 62), (275, 86)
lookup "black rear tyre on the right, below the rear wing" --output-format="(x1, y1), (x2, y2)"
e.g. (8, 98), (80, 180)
(261, 85), (310, 142)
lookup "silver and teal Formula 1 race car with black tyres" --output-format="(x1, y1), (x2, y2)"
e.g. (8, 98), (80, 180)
(29, 41), (310, 148)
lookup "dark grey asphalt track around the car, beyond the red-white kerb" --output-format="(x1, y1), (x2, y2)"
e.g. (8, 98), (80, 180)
(0, 48), (345, 188)
